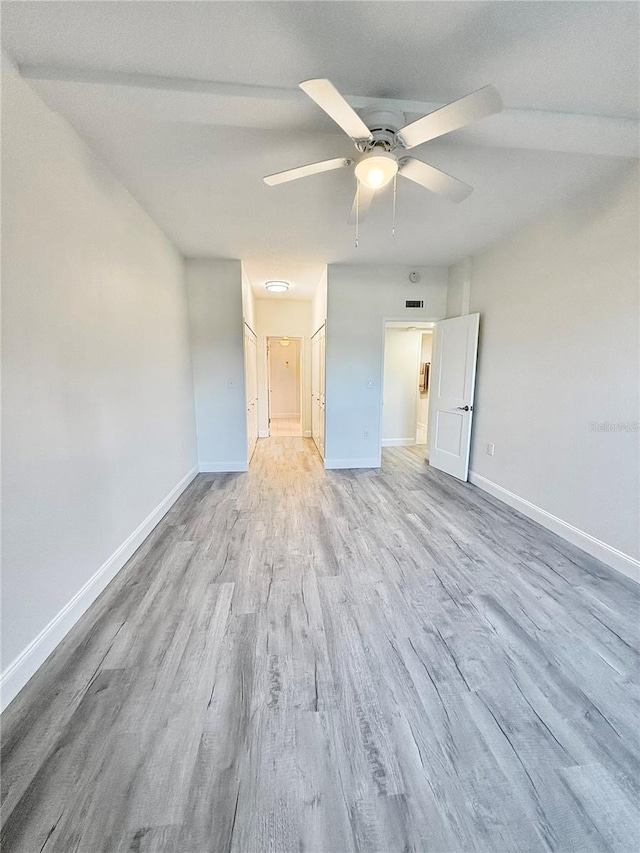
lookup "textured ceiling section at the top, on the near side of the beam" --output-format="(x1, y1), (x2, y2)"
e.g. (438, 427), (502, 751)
(3, 0), (638, 116)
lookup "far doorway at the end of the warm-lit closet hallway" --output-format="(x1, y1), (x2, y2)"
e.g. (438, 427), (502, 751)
(267, 336), (302, 437)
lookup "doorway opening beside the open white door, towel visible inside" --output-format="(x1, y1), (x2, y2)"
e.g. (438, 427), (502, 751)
(381, 321), (433, 451)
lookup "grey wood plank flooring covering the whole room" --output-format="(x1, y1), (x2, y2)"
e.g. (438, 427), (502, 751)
(2, 437), (640, 853)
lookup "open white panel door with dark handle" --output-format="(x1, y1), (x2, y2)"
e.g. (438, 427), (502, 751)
(429, 314), (480, 480)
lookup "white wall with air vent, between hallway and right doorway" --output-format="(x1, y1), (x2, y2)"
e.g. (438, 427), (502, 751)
(325, 264), (447, 468)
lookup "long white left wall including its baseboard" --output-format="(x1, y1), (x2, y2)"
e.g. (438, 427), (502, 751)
(2, 63), (196, 703)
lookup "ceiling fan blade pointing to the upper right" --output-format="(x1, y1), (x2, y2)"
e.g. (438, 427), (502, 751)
(398, 86), (502, 148)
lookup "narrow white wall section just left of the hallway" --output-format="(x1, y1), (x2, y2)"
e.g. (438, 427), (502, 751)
(187, 259), (247, 471)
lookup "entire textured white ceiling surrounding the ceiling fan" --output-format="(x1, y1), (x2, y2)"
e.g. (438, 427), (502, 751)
(3, 0), (639, 295)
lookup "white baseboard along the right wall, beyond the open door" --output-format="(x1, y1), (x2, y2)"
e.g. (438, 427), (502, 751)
(469, 471), (640, 583)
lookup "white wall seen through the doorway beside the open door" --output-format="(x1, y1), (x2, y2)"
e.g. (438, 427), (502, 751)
(382, 328), (422, 447)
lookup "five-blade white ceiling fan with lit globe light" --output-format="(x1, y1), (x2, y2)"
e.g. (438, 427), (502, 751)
(263, 79), (502, 217)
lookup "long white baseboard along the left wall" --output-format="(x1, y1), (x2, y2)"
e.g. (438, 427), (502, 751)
(0, 467), (198, 710)
